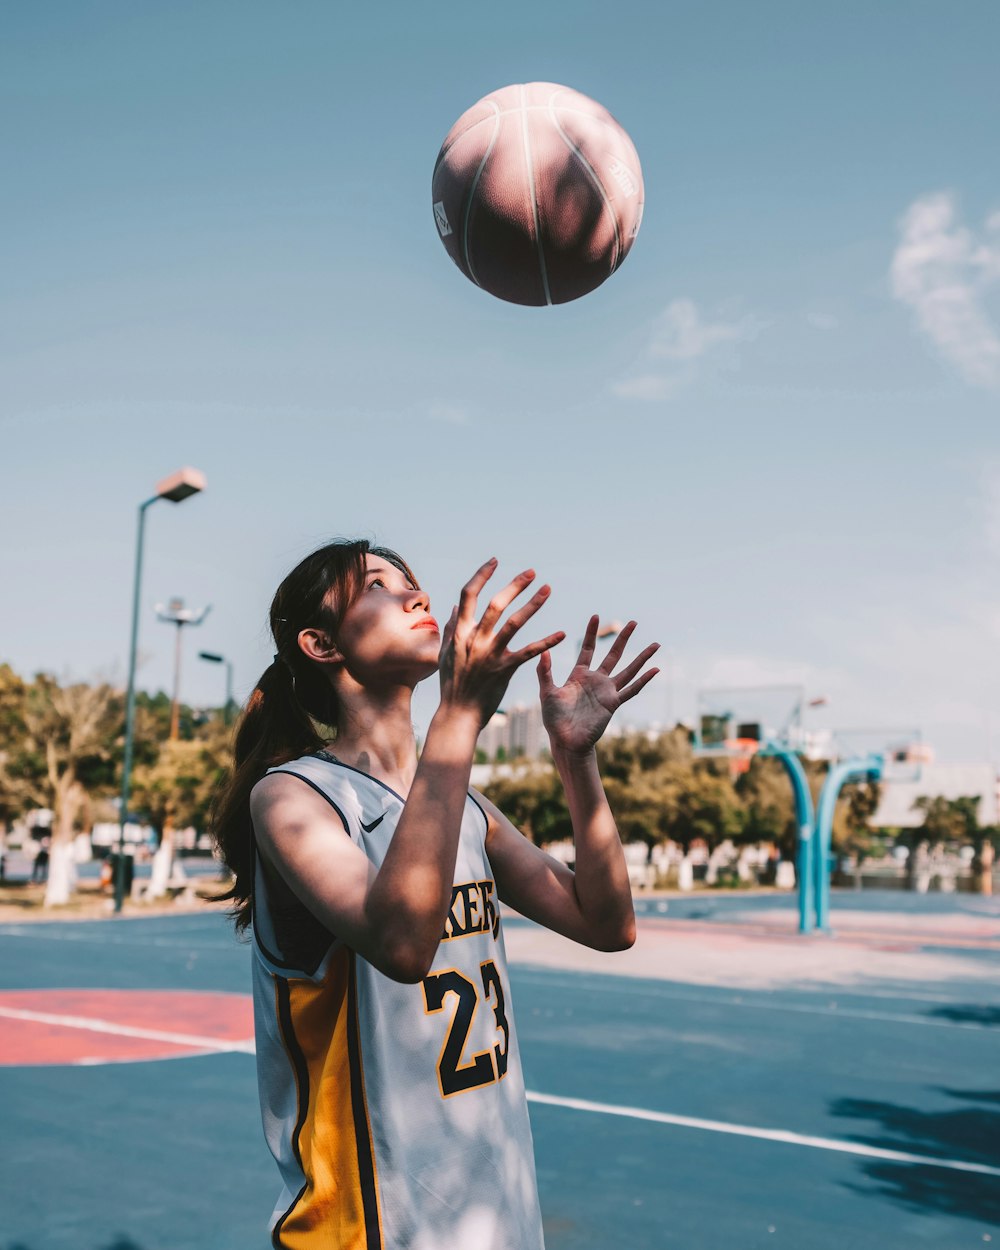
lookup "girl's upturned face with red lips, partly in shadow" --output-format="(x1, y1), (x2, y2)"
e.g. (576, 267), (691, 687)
(312, 555), (441, 685)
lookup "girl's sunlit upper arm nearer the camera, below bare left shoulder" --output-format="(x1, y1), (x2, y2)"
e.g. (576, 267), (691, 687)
(250, 773), (380, 966)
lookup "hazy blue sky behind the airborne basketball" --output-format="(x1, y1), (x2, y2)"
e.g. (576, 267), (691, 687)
(0, 0), (1000, 760)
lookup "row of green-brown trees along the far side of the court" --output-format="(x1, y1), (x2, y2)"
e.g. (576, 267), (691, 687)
(0, 665), (998, 910)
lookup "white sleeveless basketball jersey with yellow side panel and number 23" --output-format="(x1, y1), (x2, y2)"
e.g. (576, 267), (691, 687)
(253, 753), (543, 1250)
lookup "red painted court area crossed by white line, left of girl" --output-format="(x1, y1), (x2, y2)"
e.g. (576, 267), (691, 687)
(0, 990), (254, 1066)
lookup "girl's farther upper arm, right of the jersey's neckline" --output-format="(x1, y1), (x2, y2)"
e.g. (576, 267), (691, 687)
(474, 791), (594, 946)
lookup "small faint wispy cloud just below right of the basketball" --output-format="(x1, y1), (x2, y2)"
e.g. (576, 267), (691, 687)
(611, 298), (764, 401)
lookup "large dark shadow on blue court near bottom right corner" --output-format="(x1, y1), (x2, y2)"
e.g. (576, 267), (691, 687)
(830, 1089), (1000, 1224)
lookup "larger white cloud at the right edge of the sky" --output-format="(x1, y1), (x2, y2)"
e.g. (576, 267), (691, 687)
(891, 191), (1000, 388)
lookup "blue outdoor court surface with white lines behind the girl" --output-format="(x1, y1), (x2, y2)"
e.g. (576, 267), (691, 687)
(0, 891), (1000, 1250)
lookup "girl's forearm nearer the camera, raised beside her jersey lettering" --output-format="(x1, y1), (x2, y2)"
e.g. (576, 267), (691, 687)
(366, 709), (479, 980)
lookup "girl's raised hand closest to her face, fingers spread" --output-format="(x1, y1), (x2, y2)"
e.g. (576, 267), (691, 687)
(439, 558), (566, 728)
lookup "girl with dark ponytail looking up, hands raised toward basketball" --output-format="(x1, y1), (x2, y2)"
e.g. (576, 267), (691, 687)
(216, 541), (658, 1250)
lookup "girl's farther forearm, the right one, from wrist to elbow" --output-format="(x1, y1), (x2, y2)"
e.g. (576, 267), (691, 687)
(553, 751), (635, 948)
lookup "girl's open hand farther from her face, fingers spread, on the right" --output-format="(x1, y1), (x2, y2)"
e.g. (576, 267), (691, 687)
(538, 616), (660, 755)
